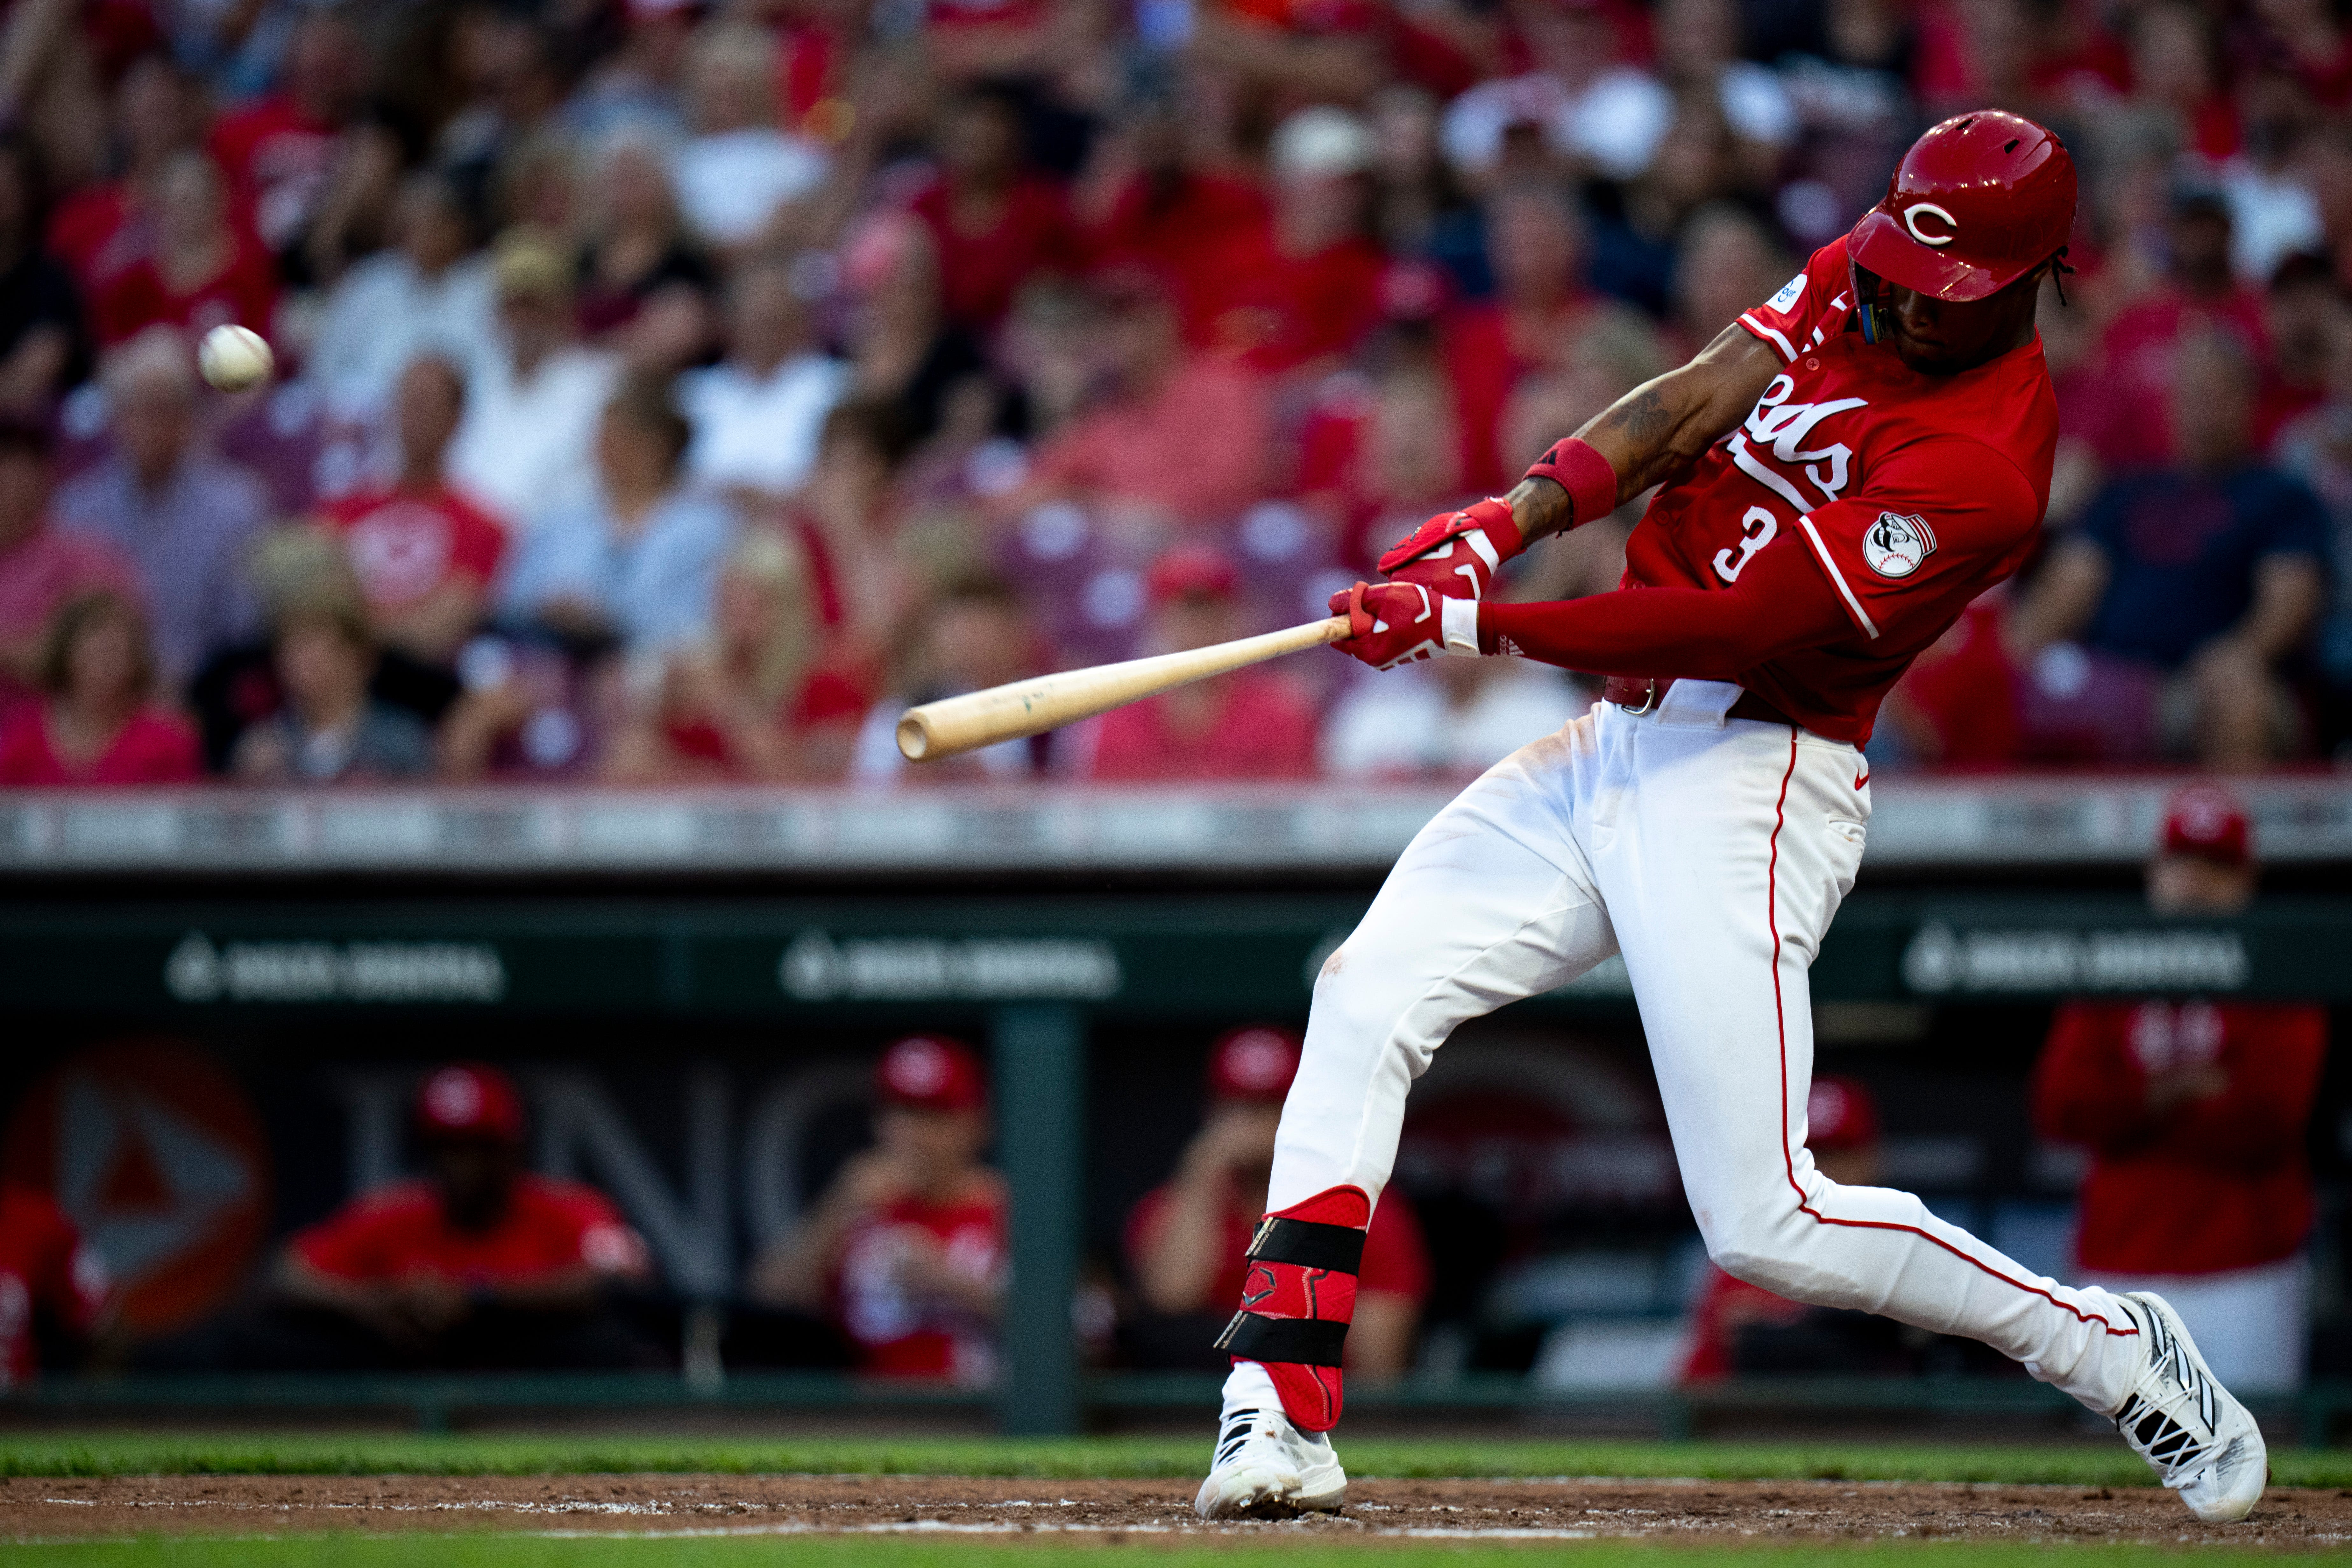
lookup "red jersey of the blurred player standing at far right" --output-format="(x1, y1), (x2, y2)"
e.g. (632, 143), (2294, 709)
(2035, 1002), (2328, 1274)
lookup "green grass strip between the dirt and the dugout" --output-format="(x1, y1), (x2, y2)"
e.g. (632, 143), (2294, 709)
(0, 1432), (2352, 1486)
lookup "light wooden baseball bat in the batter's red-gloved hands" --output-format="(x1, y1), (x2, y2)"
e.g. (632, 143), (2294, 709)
(899, 616), (1348, 762)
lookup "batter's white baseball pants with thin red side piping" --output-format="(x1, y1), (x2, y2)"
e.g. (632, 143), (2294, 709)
(1279, 682), (2138, 1415)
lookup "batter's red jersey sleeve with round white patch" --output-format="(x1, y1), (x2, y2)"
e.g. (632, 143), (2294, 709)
(1797, 440), (2042, 642)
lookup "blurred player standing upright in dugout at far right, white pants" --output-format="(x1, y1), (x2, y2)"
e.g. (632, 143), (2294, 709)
(2035, 785), (2328, 1392)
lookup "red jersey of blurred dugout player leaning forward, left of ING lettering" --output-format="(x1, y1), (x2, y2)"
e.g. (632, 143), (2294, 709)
(292, 1173), (647, 1286)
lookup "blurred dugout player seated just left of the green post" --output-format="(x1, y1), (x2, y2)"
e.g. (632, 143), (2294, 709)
(753, 1034), (1009, 1385)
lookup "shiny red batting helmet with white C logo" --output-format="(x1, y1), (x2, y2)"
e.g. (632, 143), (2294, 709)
(1846, 108), (2074, 303)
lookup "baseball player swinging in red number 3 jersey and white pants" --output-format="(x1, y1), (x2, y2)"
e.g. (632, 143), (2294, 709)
(1197, 113), (2267, 1521)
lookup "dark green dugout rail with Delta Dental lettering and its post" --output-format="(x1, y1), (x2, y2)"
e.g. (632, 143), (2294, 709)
(0, 886), (2352, 1432)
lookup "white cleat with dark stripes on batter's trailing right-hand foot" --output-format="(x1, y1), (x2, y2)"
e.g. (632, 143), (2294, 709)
(2114, 1291), (2270, 1523)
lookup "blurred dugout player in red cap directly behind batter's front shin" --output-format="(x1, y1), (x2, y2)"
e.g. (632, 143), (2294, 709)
(1119, 1025), (1430, 1380)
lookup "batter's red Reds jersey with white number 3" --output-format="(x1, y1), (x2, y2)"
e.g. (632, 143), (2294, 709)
(1625, 240), (2058, 745)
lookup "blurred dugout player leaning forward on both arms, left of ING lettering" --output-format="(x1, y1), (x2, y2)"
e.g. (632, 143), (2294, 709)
(262, 1065), (651, 1368)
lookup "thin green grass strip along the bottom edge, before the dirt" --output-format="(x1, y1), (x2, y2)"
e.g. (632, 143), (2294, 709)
(10, 1535), (2324, 1568)
